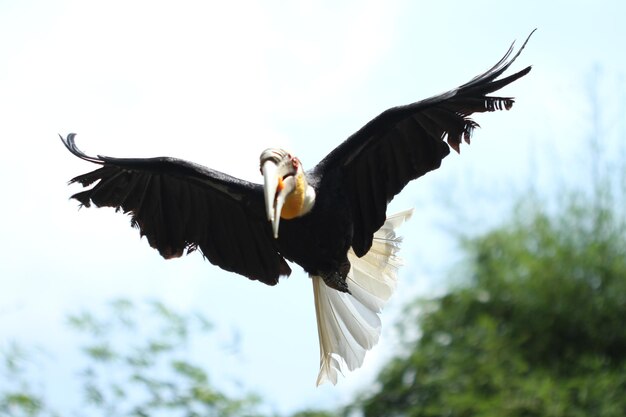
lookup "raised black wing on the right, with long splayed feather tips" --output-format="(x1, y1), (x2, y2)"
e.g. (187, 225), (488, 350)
(313, 31), (534, 256)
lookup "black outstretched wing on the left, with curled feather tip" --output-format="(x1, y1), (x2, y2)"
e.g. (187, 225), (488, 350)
(61, 133), (291, 285)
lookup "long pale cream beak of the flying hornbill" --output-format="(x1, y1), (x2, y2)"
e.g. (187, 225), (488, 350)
(261, 161), (296, 239)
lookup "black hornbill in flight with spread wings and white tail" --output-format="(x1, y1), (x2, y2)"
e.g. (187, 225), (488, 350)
(59, 31), (534, 385)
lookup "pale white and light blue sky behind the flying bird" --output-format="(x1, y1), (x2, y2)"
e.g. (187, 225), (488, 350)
(0, 0), (626, 412)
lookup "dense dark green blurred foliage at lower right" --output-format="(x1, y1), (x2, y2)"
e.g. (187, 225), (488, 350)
(355, 197), (626, 417)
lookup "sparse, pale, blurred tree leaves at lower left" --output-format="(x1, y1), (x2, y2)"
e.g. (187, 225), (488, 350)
(0, 300), (261, 417)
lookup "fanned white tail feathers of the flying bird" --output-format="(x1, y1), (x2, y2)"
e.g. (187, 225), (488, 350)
(312, 209), (413, 386)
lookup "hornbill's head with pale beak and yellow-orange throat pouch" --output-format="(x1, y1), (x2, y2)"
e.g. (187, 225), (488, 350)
(261, 148), (315, 238)
